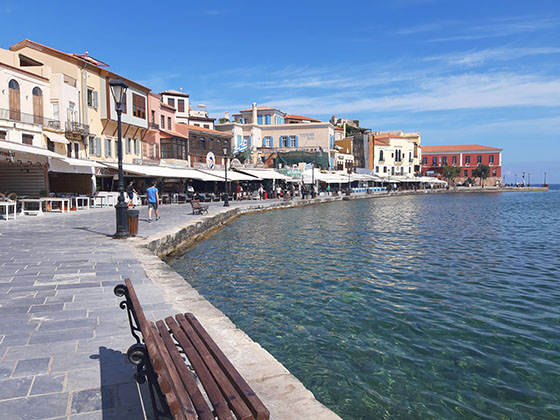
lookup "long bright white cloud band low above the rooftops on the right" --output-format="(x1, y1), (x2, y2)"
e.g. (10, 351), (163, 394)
(254, 73), (560, 114)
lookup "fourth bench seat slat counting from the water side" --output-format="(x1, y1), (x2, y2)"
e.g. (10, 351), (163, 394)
(156, 321), (214, 420)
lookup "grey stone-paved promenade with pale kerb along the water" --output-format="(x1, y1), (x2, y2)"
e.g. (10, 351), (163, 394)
(0, 200), (344, 420)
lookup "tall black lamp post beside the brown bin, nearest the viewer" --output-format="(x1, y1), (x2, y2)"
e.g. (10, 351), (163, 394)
(107, 79), (130, 239)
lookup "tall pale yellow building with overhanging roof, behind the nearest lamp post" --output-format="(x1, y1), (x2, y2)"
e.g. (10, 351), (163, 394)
(10, 40), (149, 163)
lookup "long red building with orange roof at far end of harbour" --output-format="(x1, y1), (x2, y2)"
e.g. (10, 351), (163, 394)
(422, 144), (503, 185)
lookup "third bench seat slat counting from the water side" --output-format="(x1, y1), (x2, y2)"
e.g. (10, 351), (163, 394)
(165, 317), (234, 420)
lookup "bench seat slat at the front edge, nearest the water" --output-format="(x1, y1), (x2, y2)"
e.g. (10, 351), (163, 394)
(185, 313), (270, 420)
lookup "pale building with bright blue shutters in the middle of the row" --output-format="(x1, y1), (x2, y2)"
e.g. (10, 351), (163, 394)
(216, 103), (335, 168)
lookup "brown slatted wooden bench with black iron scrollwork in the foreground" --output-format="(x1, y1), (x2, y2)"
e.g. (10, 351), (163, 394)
(114, 279), (270, 420)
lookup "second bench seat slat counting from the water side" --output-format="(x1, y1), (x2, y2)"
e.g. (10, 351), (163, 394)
(175, 314), (255, 420)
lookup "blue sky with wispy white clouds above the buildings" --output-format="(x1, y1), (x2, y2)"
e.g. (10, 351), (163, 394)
(0, 0), (560, 183)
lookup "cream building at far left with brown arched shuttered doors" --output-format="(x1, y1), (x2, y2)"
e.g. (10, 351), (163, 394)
(0, 49), (59, 196)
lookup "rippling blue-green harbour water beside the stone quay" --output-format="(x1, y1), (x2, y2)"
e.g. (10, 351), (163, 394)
(171, 190), (560, 419)
